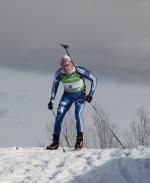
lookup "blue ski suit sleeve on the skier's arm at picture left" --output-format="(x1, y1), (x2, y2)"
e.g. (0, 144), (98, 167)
(50, 69), (61, 101)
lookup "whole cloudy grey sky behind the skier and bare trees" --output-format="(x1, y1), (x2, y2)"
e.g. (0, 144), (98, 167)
(0, 0), (150, 146)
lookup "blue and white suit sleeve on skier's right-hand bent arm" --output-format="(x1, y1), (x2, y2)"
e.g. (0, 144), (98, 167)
(76, 66), (97, 96)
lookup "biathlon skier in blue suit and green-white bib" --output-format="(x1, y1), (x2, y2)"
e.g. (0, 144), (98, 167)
(46, 55), (97, 150)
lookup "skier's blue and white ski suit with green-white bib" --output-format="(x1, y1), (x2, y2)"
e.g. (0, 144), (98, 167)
(50, 66), (97, 135)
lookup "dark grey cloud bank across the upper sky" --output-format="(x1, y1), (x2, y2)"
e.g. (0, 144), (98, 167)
(0, 0), (150, 84)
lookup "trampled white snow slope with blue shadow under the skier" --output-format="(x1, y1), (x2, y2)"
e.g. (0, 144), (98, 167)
(0, 147), (150, 183)
